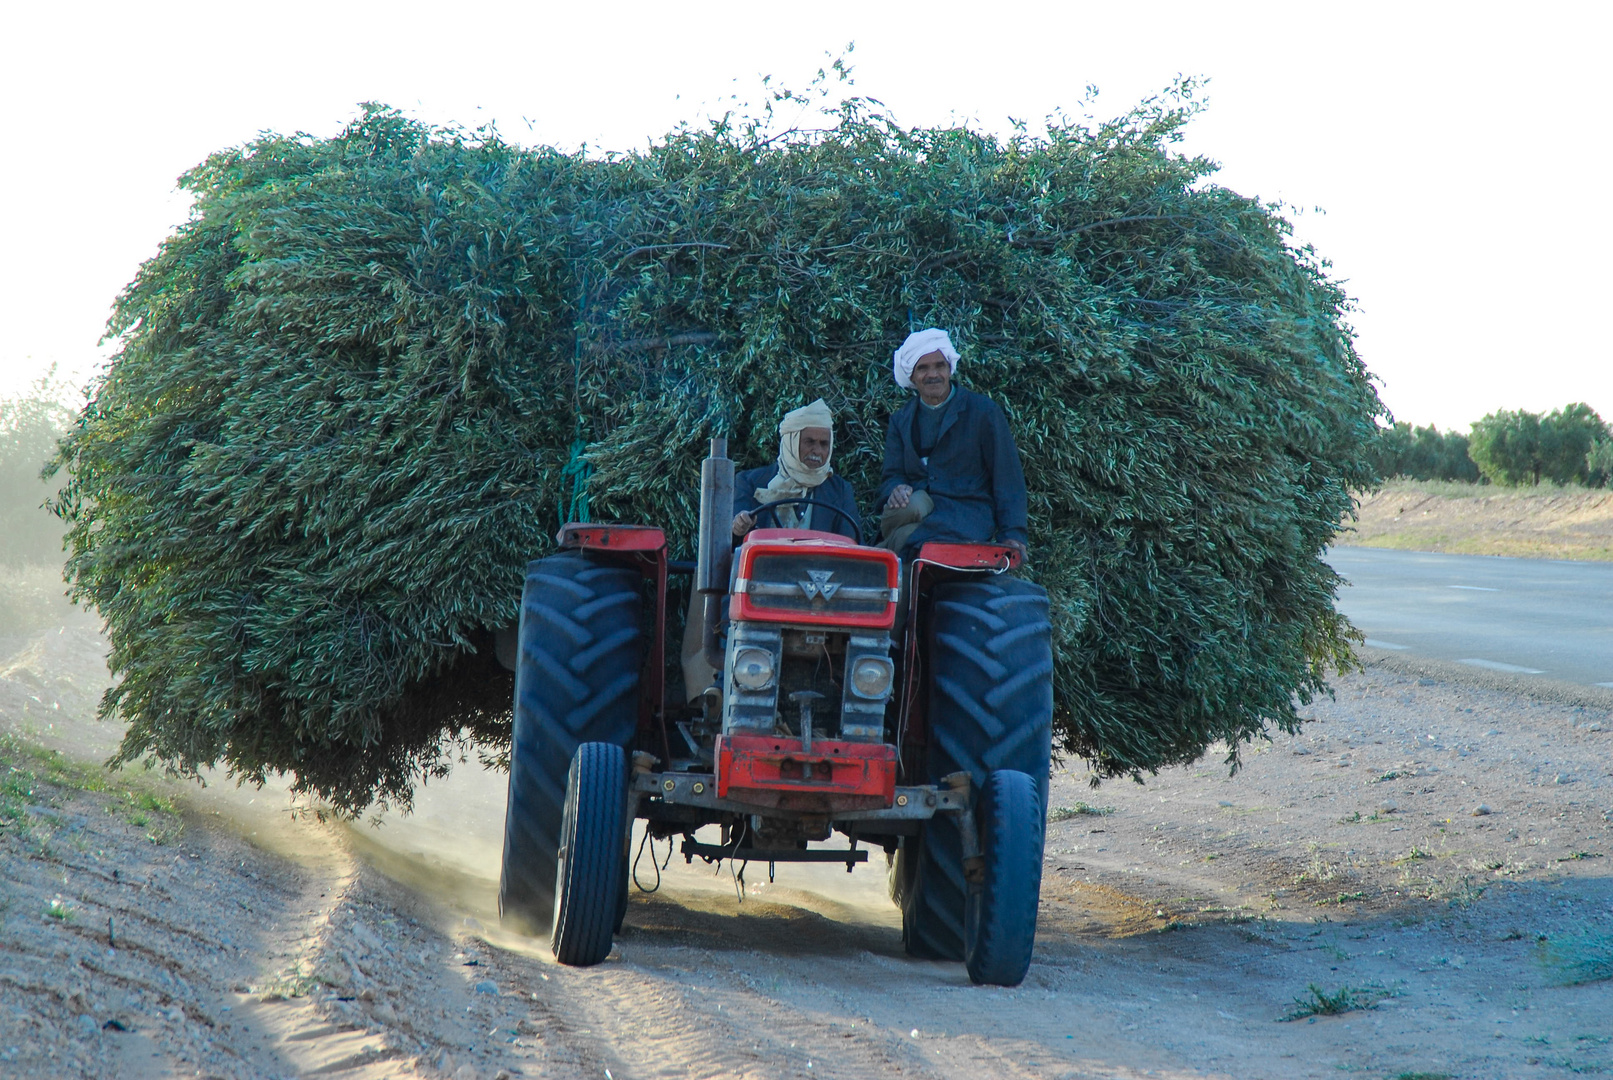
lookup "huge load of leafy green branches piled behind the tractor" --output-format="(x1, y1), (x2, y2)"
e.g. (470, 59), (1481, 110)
(58, 93), (1382, 811)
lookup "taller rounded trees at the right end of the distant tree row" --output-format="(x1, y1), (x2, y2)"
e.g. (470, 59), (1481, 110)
(1468, 401), (1610, 485)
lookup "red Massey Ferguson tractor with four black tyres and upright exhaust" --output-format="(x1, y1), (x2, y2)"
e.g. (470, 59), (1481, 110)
(498, 438), (1053, 987)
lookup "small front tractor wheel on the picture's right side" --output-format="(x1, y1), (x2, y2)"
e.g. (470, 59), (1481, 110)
(963, 769), (1044, 987)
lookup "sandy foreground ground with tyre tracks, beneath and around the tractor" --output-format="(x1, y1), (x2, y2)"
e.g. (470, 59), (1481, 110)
(0, 567), (1613, 1080)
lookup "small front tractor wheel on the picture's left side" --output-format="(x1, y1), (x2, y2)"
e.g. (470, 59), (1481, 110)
(548, 743), (627, 967)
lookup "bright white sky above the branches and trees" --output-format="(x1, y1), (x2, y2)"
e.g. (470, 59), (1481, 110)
(0, 0), (1613, 427)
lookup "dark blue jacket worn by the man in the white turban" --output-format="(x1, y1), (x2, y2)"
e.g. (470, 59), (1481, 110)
(877, 384), (1027, 550)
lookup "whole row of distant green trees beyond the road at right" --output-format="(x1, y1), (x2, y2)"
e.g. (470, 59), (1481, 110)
(1378, 401), (1613, 487)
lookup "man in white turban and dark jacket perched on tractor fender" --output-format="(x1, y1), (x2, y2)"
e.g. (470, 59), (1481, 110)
(879, 329), (1026, 558)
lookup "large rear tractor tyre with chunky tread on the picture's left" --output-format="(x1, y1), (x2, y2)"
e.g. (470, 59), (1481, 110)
(498, 551), (644, 933)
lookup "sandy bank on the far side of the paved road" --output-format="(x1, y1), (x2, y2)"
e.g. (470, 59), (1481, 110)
(1339, 480), (1613, 559)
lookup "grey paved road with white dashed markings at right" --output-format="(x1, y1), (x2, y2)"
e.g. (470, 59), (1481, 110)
(1327, 548), (1613, 687)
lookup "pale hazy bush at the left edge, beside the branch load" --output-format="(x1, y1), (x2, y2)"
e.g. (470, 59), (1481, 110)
(0, 374), (73, 564)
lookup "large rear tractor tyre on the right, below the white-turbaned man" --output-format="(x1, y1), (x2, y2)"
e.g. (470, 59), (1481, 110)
(890, 577), (1053, 961)
